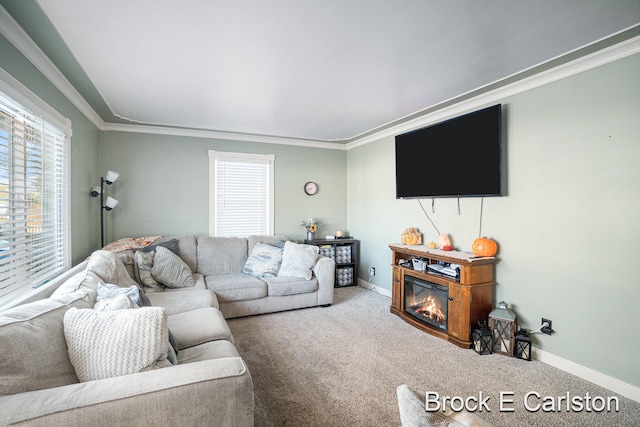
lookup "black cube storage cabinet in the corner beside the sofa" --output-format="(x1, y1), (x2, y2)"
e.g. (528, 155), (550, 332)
(305, 239), (360, 288)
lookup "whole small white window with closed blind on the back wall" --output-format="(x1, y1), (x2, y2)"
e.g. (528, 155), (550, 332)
(209, 150), (274, 237)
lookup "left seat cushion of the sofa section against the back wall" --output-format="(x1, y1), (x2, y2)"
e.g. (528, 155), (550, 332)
(204, 273), (267, 302)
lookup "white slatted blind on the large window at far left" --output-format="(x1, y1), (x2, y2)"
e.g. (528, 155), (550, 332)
(0, 92), (69, 305)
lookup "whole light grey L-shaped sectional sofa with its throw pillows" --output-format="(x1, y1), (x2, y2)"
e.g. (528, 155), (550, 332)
(0, 236), (335, 426)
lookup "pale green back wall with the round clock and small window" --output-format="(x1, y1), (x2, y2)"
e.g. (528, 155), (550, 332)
(100, 132), (347, 240)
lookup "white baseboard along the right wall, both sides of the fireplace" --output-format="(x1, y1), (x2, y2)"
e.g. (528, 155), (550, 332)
(358, 279), (640, 403)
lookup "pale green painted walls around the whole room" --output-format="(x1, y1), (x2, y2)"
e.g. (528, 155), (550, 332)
(0, 6), (640, 392)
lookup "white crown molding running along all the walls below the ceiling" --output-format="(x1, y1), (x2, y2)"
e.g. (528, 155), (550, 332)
(0, 5), (640, 151)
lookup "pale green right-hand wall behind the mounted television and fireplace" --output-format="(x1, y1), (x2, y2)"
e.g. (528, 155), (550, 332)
(347, 55), (640, 386)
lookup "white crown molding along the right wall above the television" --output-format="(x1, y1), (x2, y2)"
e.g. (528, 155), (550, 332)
(345, 36), (640, 150)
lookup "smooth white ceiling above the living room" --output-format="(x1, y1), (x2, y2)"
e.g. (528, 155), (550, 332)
(38, 0), (640, 141)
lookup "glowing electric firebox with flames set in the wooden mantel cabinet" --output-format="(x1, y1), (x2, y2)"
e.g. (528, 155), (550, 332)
(404, 275), (449, 332)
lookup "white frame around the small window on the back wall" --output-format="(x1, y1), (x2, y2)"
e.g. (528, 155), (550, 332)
(208, 150), (275, 237)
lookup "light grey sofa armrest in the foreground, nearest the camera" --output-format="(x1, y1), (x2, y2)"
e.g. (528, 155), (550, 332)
(0, 357), (254, 427)
